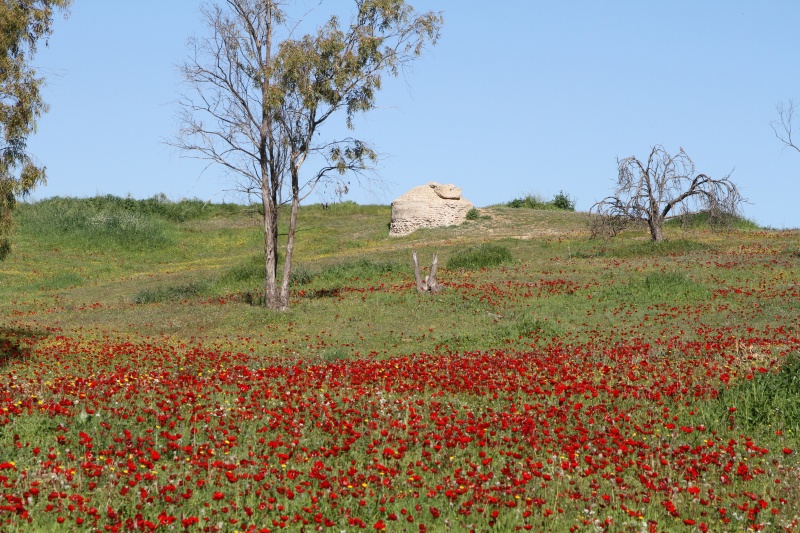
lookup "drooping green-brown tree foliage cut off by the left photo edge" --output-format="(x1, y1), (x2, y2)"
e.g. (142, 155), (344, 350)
(0, 0), (71, 258)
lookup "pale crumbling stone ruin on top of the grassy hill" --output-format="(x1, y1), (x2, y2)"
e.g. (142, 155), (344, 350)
(389, 181), (474, 237)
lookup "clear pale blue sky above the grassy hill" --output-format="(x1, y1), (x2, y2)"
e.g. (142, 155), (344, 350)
(29, 0), (800, 228)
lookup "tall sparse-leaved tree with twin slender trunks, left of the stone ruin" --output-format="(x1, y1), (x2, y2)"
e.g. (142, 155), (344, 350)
(170, 0), (442, 309)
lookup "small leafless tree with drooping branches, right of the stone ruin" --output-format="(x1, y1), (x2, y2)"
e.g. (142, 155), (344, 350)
(590, 145), (743, 241)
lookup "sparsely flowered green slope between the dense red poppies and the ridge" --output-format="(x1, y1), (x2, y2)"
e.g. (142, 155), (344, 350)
(0, 198), (798, 356)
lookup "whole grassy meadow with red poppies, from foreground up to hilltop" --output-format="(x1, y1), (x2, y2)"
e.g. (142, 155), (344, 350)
(0, 197), (800, 532)
